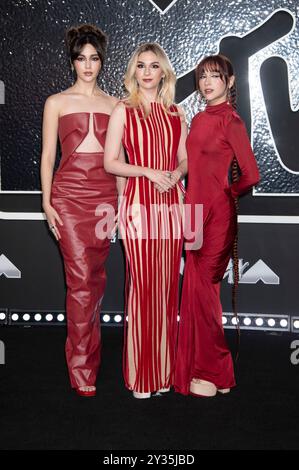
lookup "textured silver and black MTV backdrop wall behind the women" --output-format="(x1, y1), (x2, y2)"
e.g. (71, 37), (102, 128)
(0, 0), (299, 331)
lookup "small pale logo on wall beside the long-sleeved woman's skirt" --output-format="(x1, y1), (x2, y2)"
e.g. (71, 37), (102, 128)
(223, 259), (280, 285)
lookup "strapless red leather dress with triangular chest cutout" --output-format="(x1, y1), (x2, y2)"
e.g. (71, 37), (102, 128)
(51, 112), (117, 388)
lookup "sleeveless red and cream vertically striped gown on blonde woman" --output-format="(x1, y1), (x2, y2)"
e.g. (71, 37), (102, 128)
(119, 102), (183, 392)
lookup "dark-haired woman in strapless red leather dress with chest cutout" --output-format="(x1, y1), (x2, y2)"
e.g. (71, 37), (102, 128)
(41, 25), (122, 396)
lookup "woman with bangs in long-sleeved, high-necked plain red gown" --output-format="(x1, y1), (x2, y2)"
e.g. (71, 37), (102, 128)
(175, 55), (259, 396)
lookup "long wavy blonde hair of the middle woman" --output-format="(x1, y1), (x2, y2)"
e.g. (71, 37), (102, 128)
(124, 42), (176, 111)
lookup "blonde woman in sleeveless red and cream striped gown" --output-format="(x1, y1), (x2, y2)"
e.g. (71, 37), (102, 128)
(104, 43), (187, 398)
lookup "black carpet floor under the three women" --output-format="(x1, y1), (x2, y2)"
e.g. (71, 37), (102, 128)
(0, 327), (299, 450)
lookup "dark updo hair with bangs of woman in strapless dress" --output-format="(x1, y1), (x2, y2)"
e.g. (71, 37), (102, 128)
(66, 24), (108, 66)
